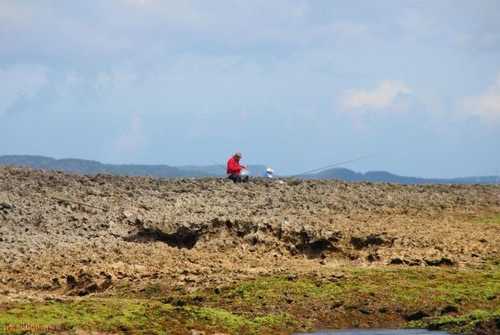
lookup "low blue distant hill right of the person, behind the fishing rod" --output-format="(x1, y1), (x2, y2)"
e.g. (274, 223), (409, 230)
(301, 168), (500, 184)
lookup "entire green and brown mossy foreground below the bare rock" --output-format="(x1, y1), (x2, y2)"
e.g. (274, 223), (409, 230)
(0, 265), (500, 334)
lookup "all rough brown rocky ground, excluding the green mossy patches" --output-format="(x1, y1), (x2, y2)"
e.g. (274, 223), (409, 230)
(0, 167), (500, 334)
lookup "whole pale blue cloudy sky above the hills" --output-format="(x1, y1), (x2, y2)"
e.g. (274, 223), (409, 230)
(0, 0), (500, 177)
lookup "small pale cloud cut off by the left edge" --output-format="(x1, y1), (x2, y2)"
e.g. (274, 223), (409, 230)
(0, 65), (48, 115)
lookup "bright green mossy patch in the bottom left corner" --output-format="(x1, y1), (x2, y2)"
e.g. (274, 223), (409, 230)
(0, 298), (294, 334)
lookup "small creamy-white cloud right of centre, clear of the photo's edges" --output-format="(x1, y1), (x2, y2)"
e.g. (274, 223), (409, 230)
(341, 80), (411, 111)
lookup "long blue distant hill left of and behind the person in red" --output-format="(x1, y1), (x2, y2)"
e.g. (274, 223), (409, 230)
(0, 155), (266, 178)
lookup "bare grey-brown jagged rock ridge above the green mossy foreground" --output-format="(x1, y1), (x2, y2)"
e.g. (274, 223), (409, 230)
(0, 168), (500, 300)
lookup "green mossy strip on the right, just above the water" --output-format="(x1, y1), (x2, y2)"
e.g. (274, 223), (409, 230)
(194, 266), (500, 311)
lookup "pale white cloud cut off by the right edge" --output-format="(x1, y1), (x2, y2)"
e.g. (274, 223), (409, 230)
(463, 73), (500, 123)
